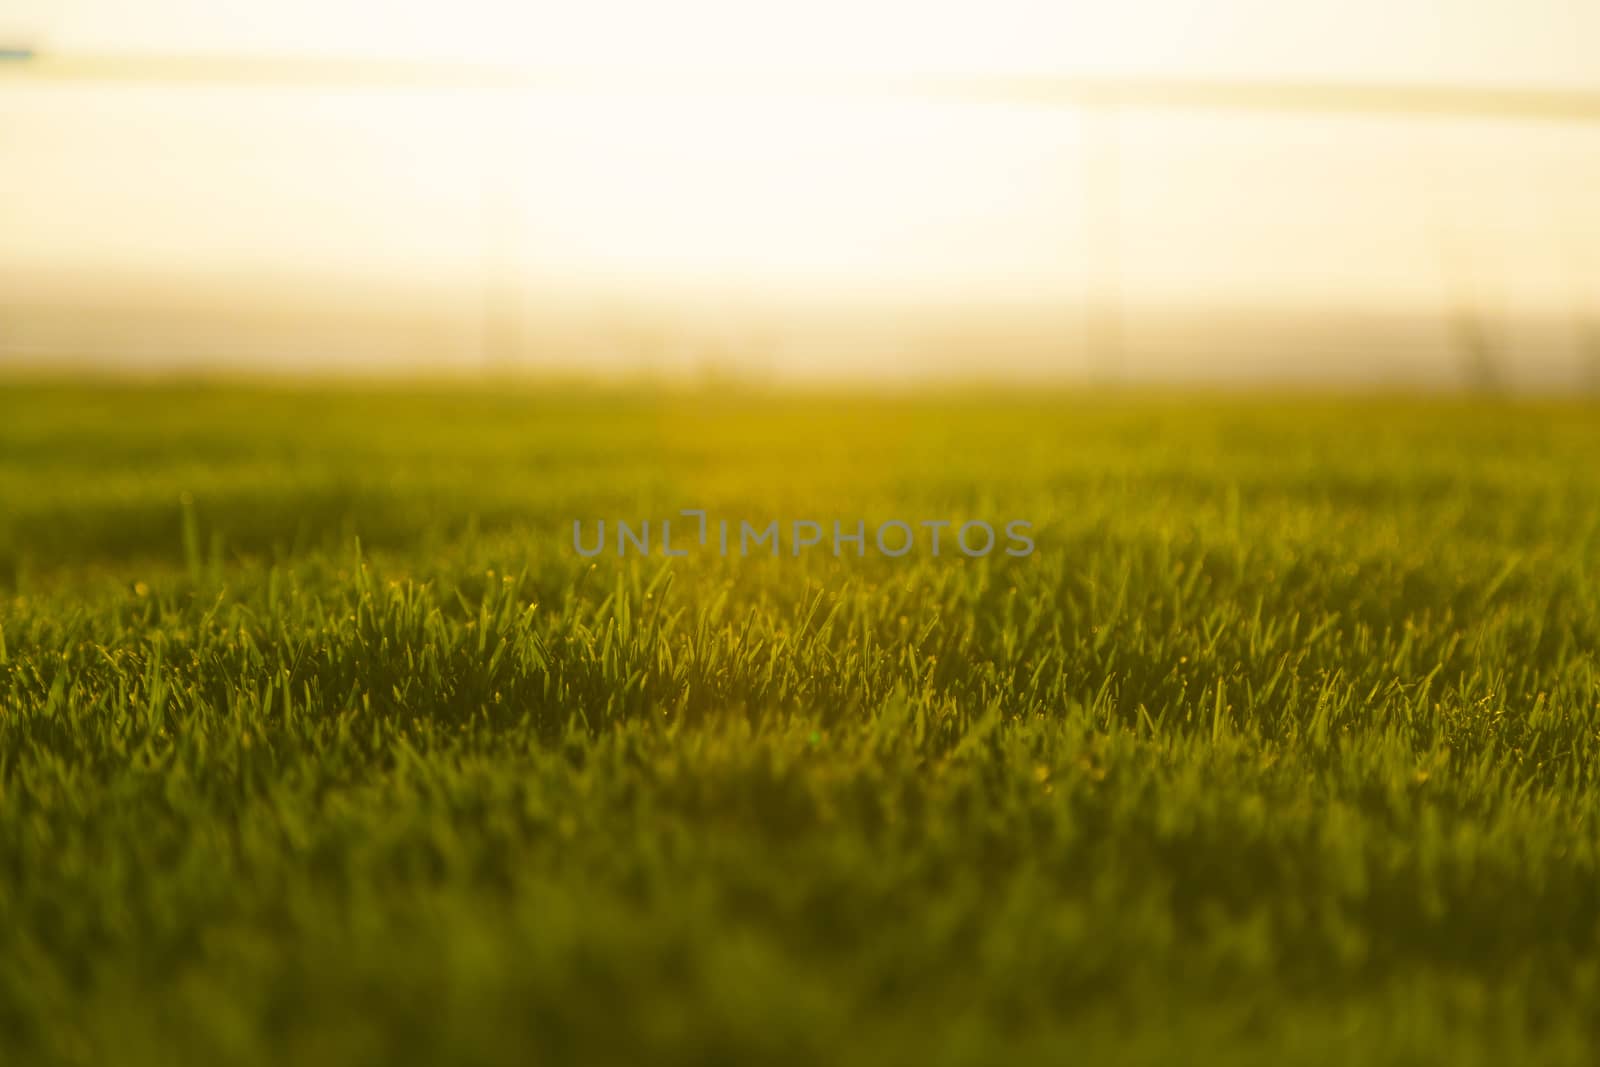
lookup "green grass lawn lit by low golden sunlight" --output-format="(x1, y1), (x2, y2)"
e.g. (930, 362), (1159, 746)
(0, 382), (1600, 1065)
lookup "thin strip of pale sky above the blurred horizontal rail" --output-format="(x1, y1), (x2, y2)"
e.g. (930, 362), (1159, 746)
(9, 0), (1600, 85)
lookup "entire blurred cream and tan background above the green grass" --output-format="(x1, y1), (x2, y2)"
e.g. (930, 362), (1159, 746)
(0, 0), (1600, 390)
